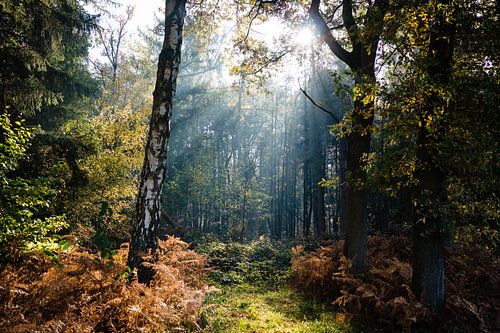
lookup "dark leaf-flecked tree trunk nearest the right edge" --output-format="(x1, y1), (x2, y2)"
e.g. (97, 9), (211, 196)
(412, 0), (455, 316)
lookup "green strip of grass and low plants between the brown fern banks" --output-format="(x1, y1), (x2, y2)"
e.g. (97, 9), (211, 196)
(193, 242), (361, 333)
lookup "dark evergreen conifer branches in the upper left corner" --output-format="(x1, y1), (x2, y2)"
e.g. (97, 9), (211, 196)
(0, 0), (96, 115)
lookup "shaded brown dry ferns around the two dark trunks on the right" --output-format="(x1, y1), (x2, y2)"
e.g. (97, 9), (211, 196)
(292, 236), (500, 332)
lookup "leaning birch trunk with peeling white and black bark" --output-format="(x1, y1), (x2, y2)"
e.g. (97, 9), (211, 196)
(128, 0), (186, 283)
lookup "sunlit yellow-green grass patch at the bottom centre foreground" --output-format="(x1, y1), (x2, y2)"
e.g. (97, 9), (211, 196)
(201, 284), (352, 333)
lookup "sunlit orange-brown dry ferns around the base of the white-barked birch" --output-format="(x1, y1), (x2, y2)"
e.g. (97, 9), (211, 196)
(0, 238), (208, 332)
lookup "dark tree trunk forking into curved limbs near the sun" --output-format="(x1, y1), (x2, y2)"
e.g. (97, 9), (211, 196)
(309, 0), (388, 273)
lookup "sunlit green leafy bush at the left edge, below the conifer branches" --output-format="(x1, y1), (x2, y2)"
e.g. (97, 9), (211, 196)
(0, 114), (66, 260)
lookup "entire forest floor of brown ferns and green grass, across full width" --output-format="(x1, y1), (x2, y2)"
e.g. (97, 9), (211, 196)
(0, 236), (500, 333)
